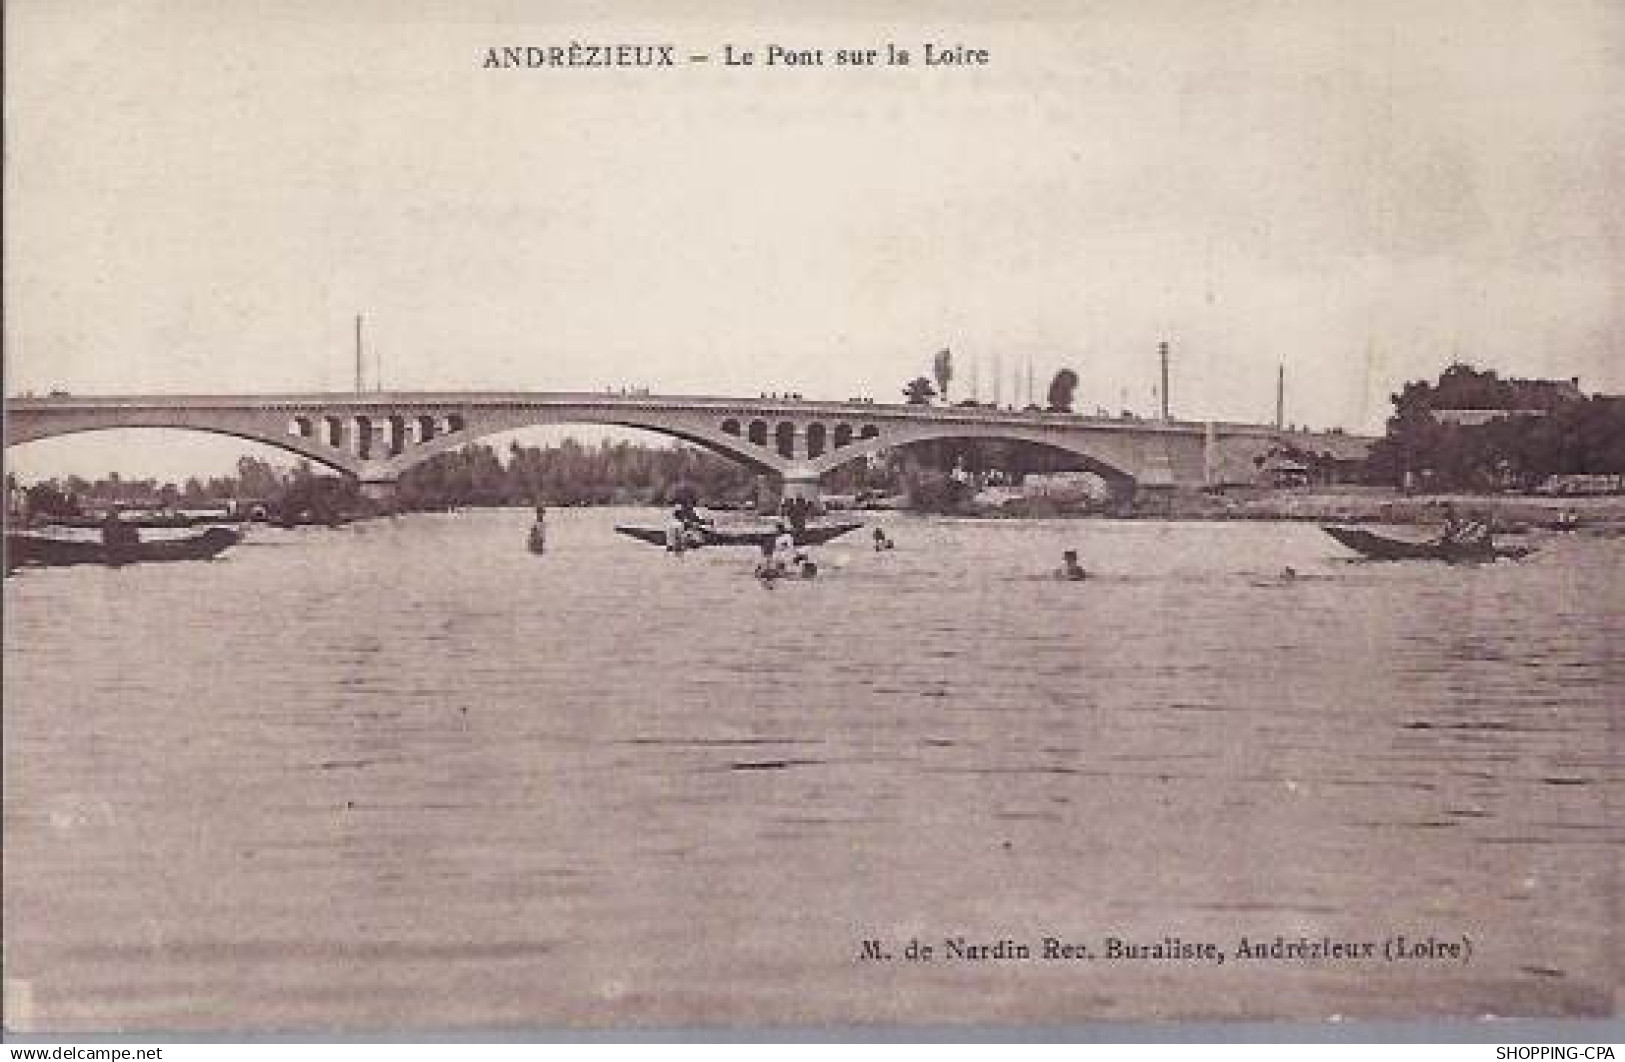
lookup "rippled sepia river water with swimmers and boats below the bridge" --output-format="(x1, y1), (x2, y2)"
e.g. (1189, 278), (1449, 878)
(3, 510), (1625, 1031)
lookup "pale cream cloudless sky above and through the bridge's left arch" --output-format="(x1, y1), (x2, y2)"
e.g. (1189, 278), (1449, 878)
(5, 0), (1625, 474)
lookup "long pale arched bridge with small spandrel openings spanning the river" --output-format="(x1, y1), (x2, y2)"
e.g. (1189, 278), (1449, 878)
(5, 391), (1372, 499)
